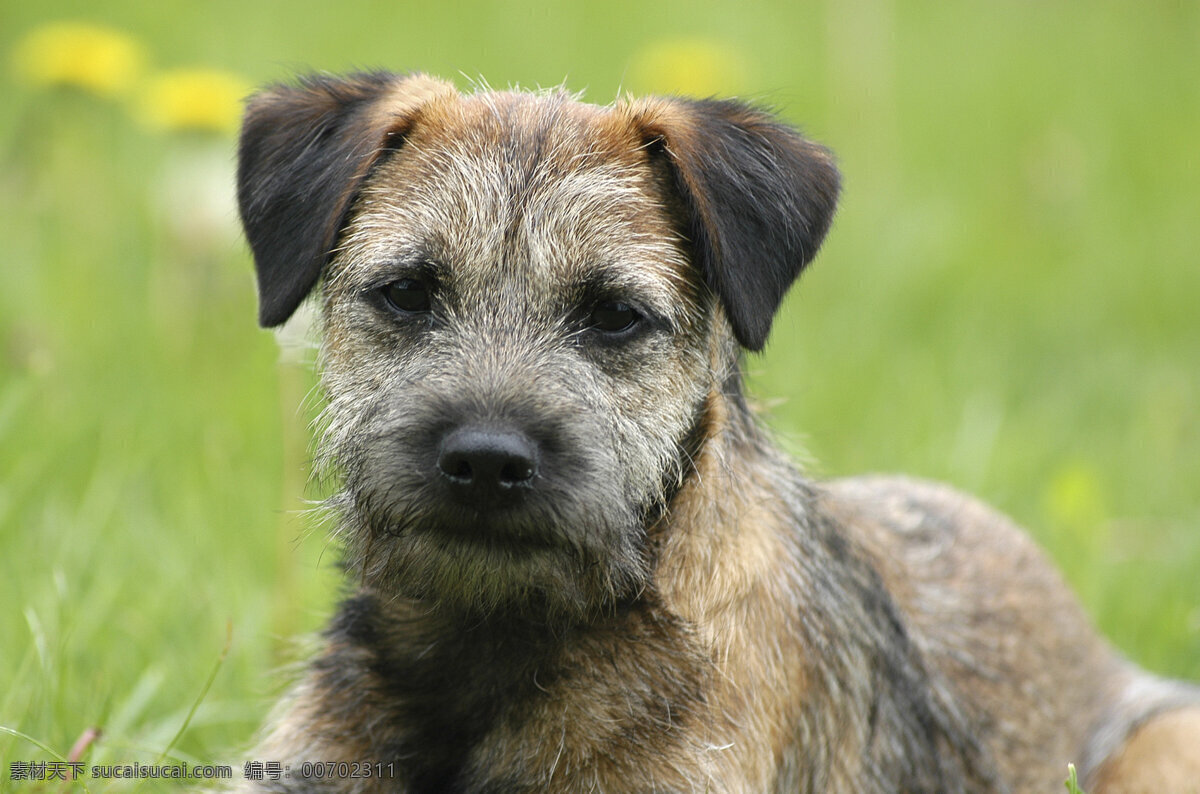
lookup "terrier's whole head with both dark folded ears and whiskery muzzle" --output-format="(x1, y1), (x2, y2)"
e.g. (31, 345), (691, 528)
(238, 74), (838, 615)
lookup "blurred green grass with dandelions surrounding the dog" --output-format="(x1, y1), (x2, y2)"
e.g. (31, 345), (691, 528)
(0, 0), (1200, 790)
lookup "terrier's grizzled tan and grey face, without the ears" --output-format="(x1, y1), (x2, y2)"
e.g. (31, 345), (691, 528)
(324, 95), (713, 606)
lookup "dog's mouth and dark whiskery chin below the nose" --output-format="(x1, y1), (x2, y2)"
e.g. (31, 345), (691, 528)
(352, 509), (647, 622)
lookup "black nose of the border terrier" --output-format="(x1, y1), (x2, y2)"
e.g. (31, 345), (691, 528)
(438, 427), (538, 501)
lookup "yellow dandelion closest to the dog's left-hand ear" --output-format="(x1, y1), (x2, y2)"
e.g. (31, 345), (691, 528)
(140, 68), (251, 133)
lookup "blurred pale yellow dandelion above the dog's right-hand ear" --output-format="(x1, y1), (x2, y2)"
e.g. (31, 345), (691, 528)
(629, 38), (746, 96)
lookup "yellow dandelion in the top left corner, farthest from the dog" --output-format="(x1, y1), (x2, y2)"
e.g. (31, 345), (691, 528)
(13, 22), (144, 96)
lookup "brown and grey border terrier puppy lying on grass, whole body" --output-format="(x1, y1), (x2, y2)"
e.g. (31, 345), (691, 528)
(229, 73), (1200, 794)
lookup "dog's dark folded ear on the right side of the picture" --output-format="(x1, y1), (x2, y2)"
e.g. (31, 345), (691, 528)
(630, 97), (839, 350)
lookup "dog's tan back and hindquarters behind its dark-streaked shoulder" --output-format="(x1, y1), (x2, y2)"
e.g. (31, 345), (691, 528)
(820, 477), (1200, 792)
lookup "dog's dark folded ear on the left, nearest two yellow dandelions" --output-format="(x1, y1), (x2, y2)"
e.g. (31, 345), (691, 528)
(238, 72), (455, 326)
